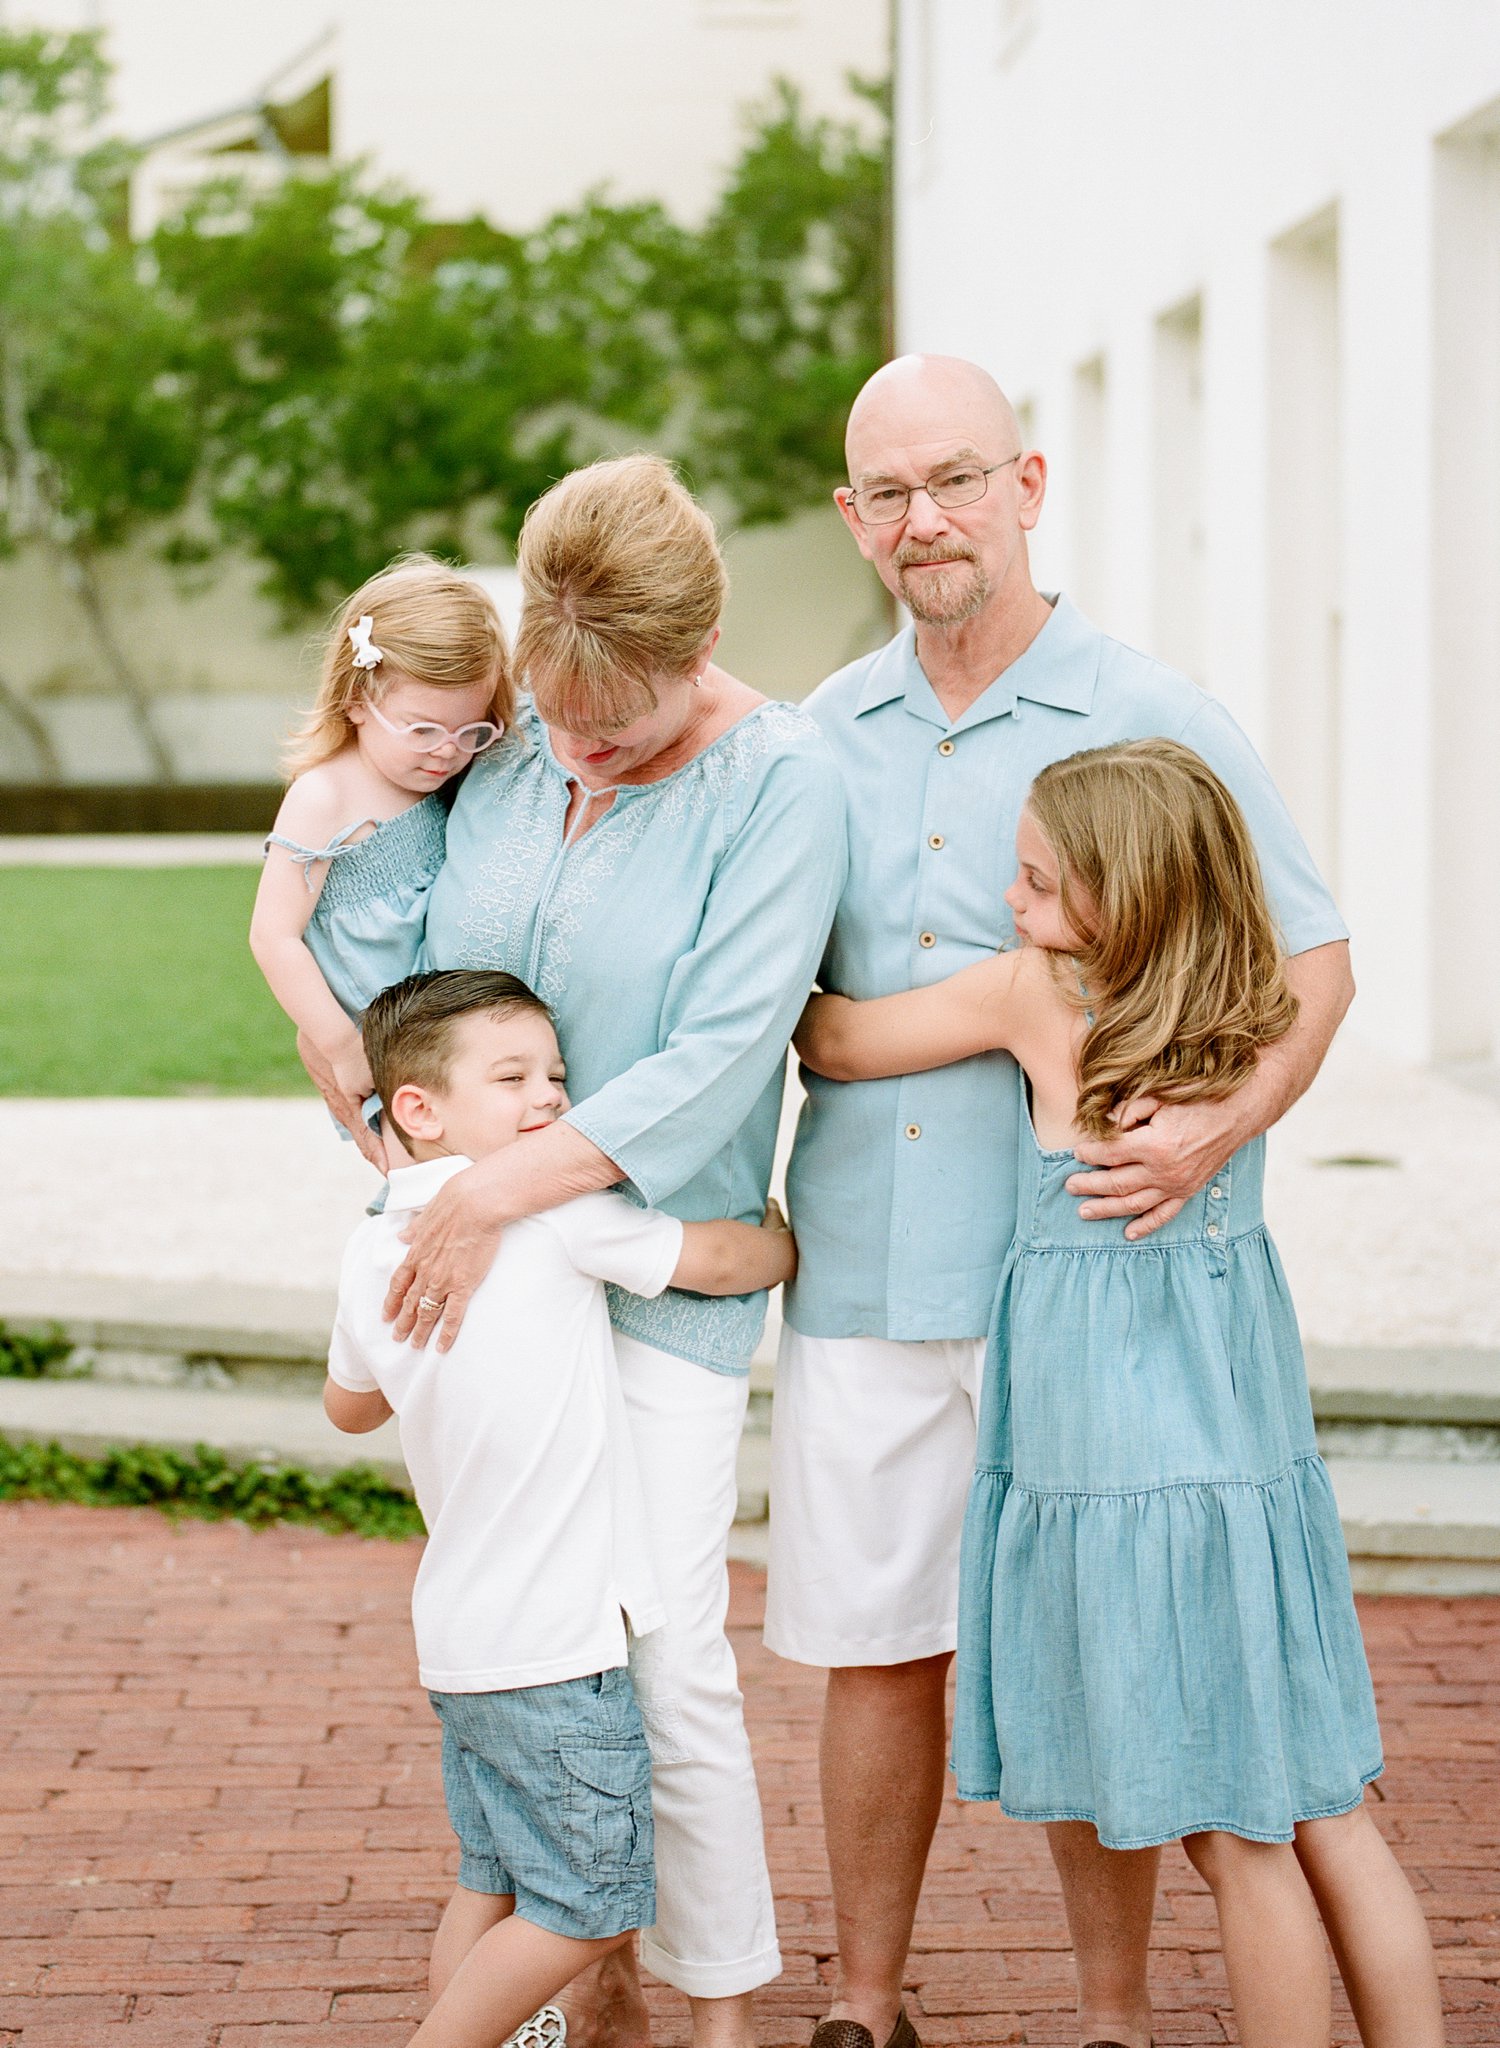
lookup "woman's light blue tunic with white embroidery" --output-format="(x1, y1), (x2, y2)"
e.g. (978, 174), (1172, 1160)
(424, 702), (846, 1372)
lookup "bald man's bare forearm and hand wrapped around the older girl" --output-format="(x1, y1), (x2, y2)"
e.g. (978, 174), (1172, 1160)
(1068, 940), (1355, 1239)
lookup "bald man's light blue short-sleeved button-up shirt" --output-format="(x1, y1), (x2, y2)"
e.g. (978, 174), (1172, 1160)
(787, 598), (1348, 1339)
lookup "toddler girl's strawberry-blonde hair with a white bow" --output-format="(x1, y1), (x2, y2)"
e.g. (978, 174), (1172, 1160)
(283, 555), (516, 776)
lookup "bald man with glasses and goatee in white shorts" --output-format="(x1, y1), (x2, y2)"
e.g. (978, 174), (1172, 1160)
(766, 356), (1352, 2048)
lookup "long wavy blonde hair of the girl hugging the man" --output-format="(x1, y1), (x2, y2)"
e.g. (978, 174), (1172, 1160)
(1027, 739), (1297, 1137)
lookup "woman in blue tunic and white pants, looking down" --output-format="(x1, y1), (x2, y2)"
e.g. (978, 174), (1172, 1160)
(387, 455), (844, 2048)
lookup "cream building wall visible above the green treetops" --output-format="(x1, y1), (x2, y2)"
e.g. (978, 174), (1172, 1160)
(26, 0), (889, 227)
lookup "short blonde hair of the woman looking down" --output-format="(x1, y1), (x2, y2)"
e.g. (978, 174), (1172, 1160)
(516, 455), (730, 733)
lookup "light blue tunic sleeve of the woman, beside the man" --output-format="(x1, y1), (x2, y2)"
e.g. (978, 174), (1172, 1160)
(566, 737), (848, 1202)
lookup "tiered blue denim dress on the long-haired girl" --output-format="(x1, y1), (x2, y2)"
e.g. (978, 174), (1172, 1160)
(953, 1077), (1381, 1849)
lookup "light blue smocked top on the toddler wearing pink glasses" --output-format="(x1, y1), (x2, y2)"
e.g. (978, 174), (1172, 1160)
(266, 797), (447, 1022)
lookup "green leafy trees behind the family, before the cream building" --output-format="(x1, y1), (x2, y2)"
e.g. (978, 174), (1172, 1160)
(0, 29), (887, 634)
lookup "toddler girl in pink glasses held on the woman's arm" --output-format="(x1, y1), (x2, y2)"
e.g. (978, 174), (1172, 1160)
(250, 555), (514, 1112)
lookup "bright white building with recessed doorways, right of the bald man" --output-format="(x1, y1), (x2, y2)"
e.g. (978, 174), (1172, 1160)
(898, 0), (1500, 1061)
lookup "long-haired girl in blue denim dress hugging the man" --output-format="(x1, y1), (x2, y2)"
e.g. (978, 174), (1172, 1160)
(797, 739), (1443, 2048)
